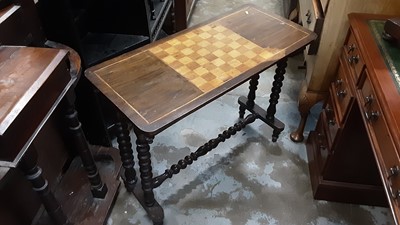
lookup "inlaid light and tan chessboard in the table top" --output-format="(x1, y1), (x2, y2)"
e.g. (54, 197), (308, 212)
(149, 24), (273, 92)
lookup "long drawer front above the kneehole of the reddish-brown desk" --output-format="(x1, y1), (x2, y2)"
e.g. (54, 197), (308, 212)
(359, 71), (400, 201)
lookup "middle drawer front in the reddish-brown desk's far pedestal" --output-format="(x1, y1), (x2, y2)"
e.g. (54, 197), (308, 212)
(330, 55), (354, 124)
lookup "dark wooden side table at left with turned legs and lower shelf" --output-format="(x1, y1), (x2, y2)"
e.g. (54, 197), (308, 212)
(0, 42), (121, 225)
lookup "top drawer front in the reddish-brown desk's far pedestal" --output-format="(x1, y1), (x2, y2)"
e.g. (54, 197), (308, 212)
(343, 29), (365, 83)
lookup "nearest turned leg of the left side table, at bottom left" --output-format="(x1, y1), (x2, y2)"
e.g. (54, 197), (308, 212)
(19, 145), (71, 225)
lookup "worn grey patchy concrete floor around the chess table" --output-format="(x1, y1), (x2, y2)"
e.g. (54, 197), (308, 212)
(107, 0), (393, 225)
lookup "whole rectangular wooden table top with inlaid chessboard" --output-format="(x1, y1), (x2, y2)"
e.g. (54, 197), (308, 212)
(85, 5), (316, 133)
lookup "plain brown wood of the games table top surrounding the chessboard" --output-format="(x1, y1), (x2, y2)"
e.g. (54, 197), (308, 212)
(85, 6), (315, 133)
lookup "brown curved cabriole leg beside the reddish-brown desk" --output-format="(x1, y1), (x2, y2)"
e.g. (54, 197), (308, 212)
(290, 82), (325, 142)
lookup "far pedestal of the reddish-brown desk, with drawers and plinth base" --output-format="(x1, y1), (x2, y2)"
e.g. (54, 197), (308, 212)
(307, 11), (387, 205)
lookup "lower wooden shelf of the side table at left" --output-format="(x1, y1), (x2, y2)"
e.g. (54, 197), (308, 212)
(34, 145), (121, 225)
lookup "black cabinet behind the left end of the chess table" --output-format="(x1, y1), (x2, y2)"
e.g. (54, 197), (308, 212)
(36, 0), (175, 146)
